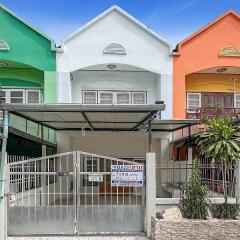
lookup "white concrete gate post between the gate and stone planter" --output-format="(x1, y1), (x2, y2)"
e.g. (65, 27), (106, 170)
(145, 152), (156, 237)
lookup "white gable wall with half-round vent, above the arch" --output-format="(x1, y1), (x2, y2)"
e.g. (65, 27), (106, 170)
(57, 10), (172, 74)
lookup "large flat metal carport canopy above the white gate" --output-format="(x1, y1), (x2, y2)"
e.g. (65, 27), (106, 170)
(0, 103), (165, 131)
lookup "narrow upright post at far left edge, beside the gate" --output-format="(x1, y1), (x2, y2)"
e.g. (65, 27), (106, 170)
(0, 111), (8, 240)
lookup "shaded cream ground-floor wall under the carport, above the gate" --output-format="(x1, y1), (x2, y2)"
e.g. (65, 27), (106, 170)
(57, 131), (171, 161)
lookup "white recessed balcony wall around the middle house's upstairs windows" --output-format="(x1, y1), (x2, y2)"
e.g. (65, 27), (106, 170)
(71, 71), (160, 104)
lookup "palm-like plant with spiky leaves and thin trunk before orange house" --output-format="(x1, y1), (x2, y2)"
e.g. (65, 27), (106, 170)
(196, 117), (240, 216)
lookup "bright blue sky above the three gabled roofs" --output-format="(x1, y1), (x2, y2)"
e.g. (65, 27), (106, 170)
(0, 0), (240, 47)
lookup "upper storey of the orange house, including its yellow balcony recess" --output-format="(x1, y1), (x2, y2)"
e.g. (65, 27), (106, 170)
(173, 11), (240, 119)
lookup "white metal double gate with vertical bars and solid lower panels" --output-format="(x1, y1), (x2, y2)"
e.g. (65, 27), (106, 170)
(8, 151), (145, 235)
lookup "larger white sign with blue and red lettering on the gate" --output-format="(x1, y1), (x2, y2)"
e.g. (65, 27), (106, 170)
(111, 165), (144, 187)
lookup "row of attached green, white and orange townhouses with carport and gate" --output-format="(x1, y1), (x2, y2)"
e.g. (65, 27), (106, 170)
(0, 3), (240, 238)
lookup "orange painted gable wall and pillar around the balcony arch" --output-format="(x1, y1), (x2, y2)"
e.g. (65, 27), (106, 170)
(173, 12), (240, 119)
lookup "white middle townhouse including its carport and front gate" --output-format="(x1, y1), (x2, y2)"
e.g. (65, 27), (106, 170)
(0, 3), (240, 240)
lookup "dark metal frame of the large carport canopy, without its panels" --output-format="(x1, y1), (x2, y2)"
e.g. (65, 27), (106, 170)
(0, 104), (165, 131)
